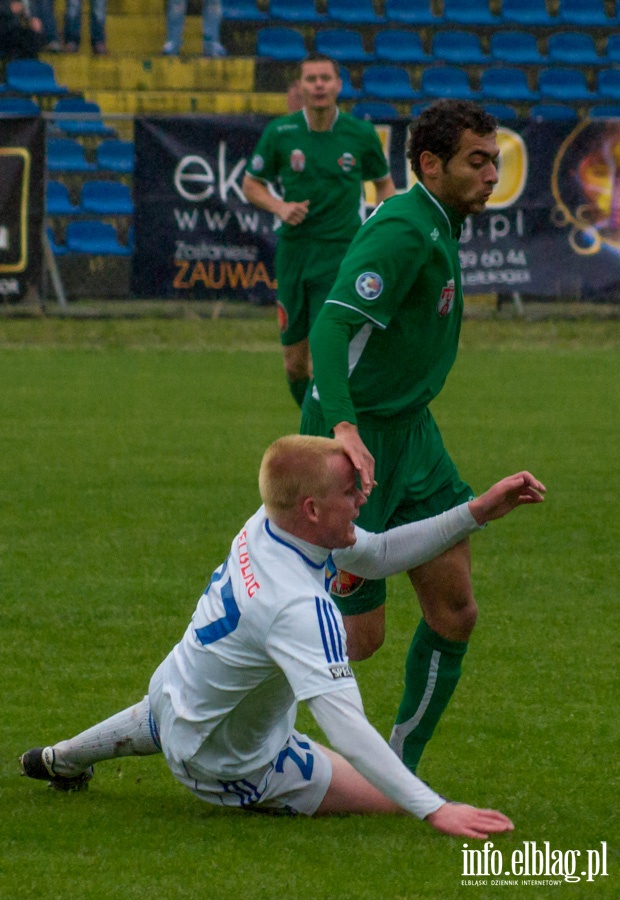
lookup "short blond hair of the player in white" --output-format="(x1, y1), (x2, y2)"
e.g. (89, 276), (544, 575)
(258, 434), (344, 515)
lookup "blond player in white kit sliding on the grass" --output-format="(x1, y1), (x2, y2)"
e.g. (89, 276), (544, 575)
(22, 435), (544, 838)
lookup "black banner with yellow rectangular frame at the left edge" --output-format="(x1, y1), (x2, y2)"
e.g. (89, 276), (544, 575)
(0, 117), (45, 300)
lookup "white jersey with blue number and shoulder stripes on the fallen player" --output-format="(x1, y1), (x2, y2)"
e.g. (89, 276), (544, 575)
(153, 507), (354, 779)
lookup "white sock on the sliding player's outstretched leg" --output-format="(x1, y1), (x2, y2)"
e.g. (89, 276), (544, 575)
(52, 695), (161, 775)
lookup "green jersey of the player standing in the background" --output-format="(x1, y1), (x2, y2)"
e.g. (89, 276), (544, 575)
(246, 110), (388, 241)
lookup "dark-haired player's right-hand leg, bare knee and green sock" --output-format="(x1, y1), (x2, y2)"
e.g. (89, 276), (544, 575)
(390, 541), (477, 772)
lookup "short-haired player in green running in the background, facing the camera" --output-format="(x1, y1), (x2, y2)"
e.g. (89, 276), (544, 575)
(243, 53), (394, 406)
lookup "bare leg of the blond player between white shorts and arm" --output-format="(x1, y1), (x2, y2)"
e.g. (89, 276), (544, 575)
(314, 745), (406, 816)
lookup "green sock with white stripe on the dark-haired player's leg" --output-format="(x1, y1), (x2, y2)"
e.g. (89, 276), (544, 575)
(390, 619), (467, 772)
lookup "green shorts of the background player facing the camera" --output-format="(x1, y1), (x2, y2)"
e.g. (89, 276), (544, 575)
(276, 239), (349, 345)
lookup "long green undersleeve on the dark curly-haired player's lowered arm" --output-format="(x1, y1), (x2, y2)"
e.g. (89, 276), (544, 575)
(310, 303), (368, 430)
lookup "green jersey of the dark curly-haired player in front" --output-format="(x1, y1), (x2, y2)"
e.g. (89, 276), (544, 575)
(310, 183), (463, 428)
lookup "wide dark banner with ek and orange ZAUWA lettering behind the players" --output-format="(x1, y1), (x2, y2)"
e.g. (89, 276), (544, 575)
(132, 116), (620, 302)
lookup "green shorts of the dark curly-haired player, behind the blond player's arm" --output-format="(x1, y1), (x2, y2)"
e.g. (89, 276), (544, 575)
(301, 402), (474, 616)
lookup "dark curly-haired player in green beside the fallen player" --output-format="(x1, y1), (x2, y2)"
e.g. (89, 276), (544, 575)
(302, 100), (499, 771)
